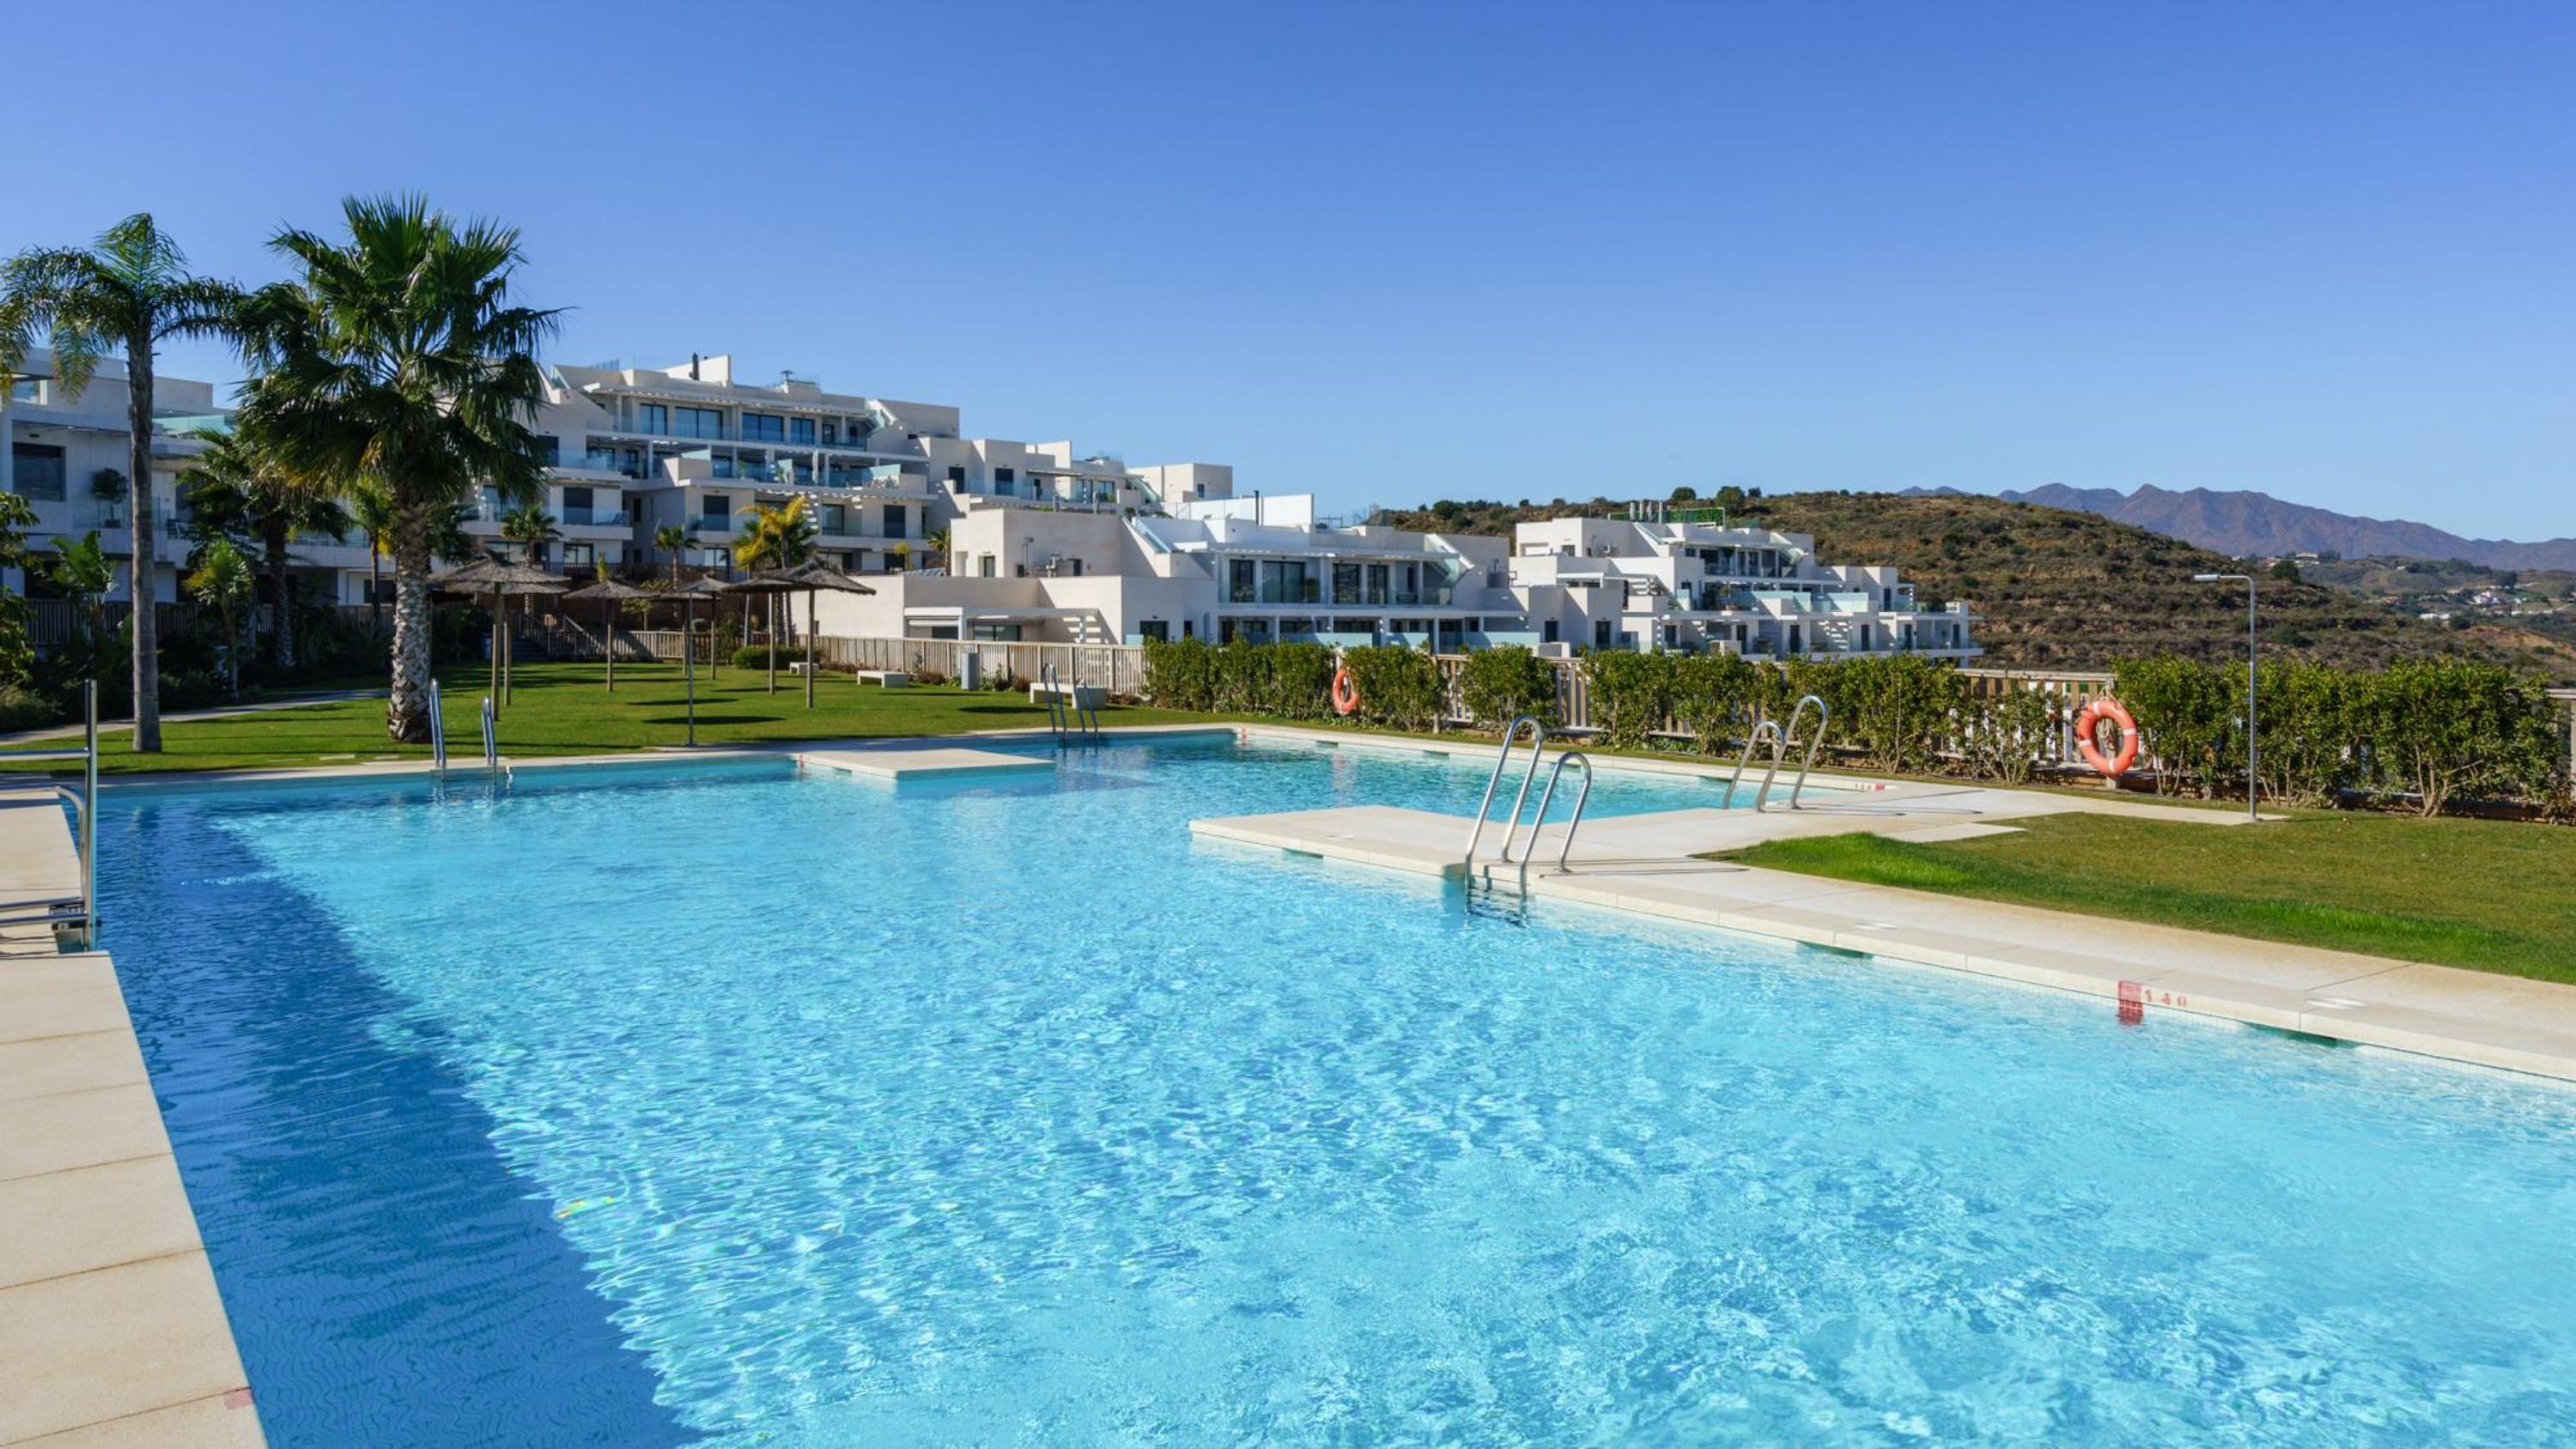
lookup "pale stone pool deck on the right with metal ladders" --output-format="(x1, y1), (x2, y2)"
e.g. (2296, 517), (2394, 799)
(1190, 728), (2576, 1081)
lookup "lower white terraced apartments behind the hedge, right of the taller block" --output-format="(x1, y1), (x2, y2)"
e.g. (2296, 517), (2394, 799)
(819, 494), (1978, 659)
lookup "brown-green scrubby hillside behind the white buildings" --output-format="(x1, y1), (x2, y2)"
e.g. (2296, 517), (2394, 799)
(1378, 494), (2576, 680)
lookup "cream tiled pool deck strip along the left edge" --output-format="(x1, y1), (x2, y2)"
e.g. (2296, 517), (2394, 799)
(0, 787), (265, 1449)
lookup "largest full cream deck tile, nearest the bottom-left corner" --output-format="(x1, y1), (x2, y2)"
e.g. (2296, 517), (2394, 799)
(0, 1251), (250, 1444)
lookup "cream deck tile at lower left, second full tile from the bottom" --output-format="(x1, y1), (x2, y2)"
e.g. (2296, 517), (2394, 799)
(0, 1155), (198, 1287)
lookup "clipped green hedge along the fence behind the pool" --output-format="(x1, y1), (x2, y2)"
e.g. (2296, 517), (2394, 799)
(1144, 641), (2571, 815)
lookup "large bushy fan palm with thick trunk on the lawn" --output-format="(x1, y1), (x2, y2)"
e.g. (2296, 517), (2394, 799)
(245, 196), (556, 743)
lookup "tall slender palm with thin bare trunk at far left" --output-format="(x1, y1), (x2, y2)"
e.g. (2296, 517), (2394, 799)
(0, 211), (242, 754)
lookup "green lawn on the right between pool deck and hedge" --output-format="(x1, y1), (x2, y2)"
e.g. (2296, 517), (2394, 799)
(1718, 813), (2576, 980)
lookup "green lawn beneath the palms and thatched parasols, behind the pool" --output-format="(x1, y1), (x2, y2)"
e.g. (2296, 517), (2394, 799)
(0, 664), (1206, 774)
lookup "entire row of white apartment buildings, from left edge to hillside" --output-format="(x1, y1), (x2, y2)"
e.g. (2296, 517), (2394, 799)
(0, 353), (1978, 659)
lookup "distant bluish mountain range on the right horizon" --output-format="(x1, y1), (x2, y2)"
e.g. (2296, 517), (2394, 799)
(1911, 484), (2576, 569)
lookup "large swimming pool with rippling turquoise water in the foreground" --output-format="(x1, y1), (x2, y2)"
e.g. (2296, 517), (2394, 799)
(100, 741), (2576, 1444)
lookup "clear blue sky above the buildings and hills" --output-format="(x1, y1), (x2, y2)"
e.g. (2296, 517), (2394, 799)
(0, 0), (2576, 538)
